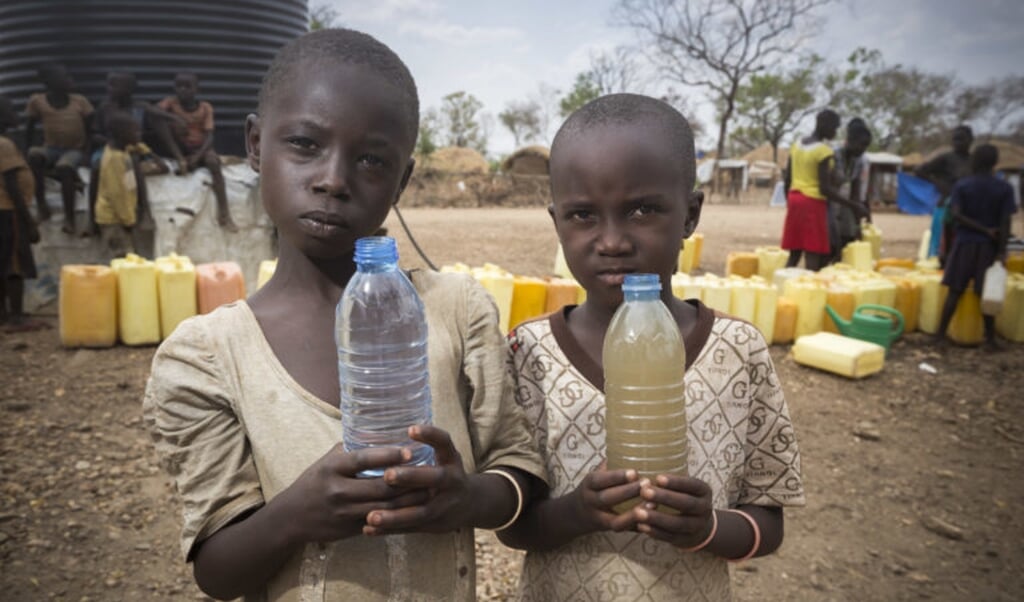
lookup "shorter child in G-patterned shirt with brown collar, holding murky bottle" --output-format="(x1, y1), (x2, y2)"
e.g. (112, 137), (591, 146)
(499, 94), (804, 601)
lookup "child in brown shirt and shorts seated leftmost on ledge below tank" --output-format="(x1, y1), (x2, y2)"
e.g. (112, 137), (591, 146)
(25, 63), (93, 234)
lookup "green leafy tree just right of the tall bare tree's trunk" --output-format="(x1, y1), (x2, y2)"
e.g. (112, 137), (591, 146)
(733, 55), (823, 163)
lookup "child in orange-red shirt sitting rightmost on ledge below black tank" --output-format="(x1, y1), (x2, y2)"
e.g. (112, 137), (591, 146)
(157, 72), (239, 232)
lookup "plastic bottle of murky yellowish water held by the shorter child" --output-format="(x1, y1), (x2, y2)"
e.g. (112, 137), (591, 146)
(601, 273), (687, 512)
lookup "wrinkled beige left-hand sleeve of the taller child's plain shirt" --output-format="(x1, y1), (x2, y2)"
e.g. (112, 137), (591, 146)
(142, 317), (264, 560)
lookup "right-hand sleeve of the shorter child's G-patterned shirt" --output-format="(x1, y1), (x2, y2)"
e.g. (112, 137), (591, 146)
(737, 329), (805, 506)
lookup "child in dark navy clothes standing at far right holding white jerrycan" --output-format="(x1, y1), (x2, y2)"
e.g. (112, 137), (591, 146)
(935, 144), (1017, 350)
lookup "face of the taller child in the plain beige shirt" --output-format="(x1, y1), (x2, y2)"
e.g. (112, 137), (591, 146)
(246, 60), (416, 259)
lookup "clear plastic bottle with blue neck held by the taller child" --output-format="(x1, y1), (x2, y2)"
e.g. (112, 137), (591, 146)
(335, 237), (434, 477)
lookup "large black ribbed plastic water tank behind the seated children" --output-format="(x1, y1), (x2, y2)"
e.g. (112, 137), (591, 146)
(0, 0), (308, 155)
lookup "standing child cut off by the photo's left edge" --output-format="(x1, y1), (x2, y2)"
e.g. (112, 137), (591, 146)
(0, 96), (43, 331)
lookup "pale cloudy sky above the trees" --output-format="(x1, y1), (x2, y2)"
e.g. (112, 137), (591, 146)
(329, 0), (1024, 157)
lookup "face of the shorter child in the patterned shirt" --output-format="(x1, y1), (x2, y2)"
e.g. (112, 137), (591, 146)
(551, 125), (700, 311)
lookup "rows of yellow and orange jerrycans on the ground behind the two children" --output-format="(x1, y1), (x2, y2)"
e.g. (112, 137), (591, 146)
(59, 224), (1024, 378)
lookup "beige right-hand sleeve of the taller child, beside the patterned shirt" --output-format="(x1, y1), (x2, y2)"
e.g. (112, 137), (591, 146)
(463, 278), (547, 482)
